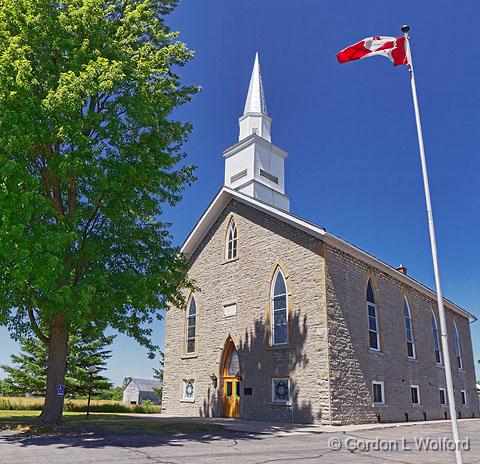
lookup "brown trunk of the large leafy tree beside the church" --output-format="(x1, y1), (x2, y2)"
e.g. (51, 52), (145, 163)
(36, 315), (68, 427)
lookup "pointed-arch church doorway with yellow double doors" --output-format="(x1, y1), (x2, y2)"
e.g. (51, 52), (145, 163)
(222, 340), (241, 417)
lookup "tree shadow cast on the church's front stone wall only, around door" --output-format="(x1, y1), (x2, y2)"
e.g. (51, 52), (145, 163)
(199, 313), (321, 423)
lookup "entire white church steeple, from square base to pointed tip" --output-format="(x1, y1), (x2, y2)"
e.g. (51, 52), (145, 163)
(223, 53), (290, 211)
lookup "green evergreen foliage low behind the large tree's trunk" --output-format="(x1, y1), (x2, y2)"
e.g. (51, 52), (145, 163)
(0, 335), (115, 399)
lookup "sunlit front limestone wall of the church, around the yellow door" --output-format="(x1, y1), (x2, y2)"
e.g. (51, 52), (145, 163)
(163, 201), (330, 423)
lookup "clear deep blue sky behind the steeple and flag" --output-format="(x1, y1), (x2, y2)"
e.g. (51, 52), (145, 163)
(0, 0), (480, 383)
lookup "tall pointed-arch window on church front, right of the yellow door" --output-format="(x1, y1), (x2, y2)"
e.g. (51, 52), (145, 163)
(270, 267), (288, 345)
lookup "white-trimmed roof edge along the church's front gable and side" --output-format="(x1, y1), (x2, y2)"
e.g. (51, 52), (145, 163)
(181, 187), (477, 321)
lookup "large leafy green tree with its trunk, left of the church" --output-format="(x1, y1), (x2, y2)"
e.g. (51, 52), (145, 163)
(0, 0), (197, 425)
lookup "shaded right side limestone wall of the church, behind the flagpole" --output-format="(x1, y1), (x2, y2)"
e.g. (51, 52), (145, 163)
(325, 247), (479, 423)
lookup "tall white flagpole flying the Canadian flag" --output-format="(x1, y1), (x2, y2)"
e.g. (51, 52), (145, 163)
(402, 25), (463, 464)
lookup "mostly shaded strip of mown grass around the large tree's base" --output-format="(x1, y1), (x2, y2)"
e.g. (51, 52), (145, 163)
(0, 410), (223, 435)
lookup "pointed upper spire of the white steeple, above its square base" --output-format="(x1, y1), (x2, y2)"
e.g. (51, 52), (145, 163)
(238, 52), (272, 142)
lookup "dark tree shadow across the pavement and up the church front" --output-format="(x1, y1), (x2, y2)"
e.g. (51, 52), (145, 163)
(0, 308), (320, 449)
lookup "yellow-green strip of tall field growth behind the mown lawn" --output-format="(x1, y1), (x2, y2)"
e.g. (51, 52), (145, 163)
(0, 397), (160, 414)
